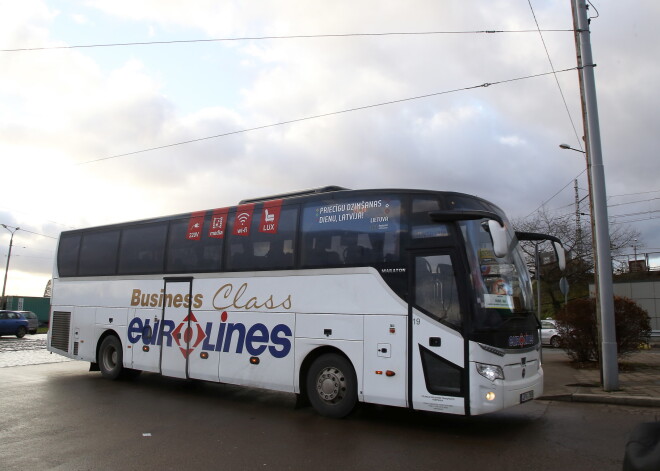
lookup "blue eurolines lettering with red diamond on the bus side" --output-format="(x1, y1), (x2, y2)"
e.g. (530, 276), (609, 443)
(128, 311), (293, 358)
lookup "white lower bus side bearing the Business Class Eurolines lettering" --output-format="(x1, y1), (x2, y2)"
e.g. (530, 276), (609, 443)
(49, 268), (407, 405)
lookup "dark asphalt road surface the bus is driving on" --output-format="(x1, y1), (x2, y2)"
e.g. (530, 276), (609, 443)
(0, 342), (659, 471)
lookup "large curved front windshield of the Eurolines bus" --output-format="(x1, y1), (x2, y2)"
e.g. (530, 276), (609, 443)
(460, 220), (534, 340)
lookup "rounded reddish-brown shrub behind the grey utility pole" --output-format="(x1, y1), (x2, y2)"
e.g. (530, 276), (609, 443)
(556, 296), (651, 362)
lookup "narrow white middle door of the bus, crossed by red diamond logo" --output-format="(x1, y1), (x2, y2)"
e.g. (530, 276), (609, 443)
(158, 278), (193, 378)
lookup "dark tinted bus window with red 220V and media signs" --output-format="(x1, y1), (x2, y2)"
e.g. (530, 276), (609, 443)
(167, 212), (227, 273)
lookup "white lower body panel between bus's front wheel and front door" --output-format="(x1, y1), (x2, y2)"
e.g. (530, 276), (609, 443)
(363, 316), (408, 407)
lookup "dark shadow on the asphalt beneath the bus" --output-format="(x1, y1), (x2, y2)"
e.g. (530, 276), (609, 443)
(60, 373), (546, 440)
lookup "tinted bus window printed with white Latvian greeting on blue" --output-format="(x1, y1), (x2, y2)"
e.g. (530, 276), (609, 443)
(301, 196), (401, 267)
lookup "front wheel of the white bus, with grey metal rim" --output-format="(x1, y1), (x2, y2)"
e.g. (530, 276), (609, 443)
(307, 353), (357, 419)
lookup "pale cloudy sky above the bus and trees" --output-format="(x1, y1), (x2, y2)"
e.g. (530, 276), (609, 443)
(0, 0), (660, 296)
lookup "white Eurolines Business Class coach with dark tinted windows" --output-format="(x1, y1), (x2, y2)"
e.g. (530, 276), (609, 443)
(48, 187), (564, 418)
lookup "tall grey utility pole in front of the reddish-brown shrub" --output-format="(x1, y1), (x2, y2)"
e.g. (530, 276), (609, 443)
(571, 0), (619, 391)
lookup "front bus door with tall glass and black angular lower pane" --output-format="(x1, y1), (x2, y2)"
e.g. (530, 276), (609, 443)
(408, 250), (469, 414)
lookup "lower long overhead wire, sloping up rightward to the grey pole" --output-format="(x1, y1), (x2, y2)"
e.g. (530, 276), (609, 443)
(76, 67), (584, 166)
